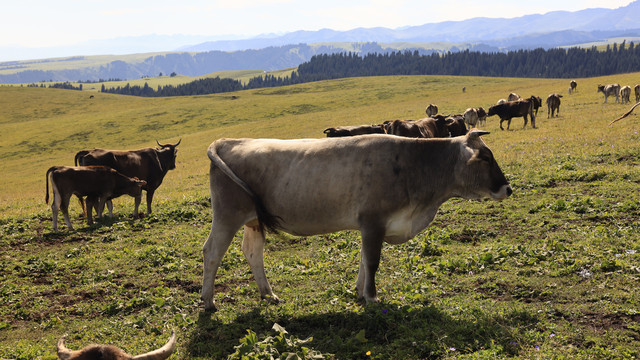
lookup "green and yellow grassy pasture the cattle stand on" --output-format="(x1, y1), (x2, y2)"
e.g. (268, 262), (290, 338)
(0, 74), (640, 359)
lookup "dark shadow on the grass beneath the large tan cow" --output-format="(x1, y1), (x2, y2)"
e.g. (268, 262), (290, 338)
(186, 303), (539, 359)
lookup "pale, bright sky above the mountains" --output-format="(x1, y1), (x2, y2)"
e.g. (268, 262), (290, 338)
(0, 0), (631, 48)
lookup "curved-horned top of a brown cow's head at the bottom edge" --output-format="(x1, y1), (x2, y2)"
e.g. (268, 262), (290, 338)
(57, 332), (176, 360)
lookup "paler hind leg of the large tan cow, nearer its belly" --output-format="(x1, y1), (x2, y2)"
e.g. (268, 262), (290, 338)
(242, 224), (280, 303)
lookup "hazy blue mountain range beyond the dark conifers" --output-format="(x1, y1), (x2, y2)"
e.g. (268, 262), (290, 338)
(0, 0), (640, 83)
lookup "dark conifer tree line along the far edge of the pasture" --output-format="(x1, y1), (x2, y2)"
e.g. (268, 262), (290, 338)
(102, 42), (640, 96)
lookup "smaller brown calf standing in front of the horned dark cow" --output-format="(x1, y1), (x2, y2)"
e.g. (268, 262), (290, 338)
(45, 166), (147, 231)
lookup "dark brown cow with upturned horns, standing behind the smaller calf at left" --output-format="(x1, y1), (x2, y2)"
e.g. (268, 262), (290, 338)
(75, 140), (180, 217)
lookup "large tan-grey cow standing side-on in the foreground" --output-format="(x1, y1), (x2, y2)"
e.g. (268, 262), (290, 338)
(201, 130), (512, 311)
